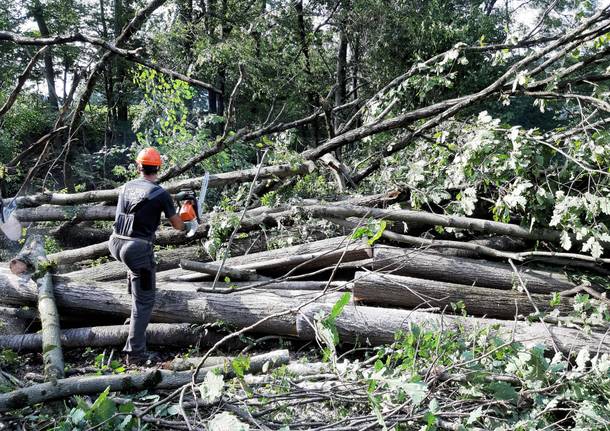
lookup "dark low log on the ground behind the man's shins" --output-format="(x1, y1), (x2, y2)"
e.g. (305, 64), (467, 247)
(0, 323), (222, 352)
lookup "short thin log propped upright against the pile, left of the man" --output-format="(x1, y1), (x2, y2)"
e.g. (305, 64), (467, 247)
(9, 235), (64, 381)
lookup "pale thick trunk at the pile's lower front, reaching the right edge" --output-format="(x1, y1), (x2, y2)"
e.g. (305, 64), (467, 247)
(297, 304), (610, 353)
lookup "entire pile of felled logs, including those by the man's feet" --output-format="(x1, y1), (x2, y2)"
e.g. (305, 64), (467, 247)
(0, 183), (610, 418)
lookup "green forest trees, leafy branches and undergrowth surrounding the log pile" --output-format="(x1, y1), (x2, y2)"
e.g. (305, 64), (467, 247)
(0, 0), (610, 430)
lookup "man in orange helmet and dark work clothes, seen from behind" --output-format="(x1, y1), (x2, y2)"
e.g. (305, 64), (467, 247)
(109, 148), (196, 364)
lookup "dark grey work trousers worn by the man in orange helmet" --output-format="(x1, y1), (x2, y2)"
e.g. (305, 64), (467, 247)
(108, 236), (156, 354)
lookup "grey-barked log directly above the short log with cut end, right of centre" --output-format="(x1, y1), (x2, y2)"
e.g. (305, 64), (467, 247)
(373, 245), (575, 293)
